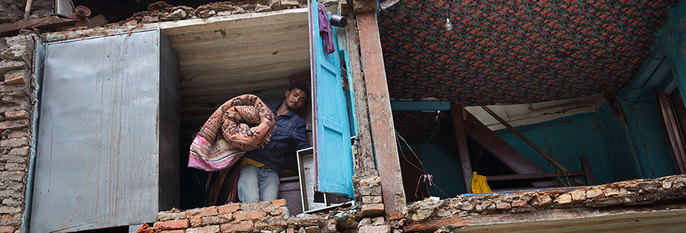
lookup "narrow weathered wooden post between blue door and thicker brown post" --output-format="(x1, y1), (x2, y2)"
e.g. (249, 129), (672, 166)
(345, 16), (376, 173)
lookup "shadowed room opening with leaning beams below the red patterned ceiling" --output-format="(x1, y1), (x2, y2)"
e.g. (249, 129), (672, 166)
(391, 93), (680, 202)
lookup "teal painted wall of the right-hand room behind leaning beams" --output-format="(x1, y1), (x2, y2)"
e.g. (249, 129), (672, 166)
(412, 100), (676, 197)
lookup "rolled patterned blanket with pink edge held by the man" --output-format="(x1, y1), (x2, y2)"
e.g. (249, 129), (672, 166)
(188, 94), (276, 171)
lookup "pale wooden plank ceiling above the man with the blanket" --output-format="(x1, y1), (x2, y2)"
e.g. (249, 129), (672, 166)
(162, 9), (310, 133)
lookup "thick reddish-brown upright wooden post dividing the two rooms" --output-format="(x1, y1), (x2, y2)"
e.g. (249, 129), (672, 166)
(357, 12), (405, 219)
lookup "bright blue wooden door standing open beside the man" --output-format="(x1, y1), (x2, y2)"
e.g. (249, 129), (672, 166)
(309, 0), (353, 197)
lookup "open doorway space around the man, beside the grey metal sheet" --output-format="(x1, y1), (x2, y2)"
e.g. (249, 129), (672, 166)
(164, 9), (312, 209)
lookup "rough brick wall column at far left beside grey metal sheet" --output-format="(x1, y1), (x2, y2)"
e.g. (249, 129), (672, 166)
(0, 35), (33, 233)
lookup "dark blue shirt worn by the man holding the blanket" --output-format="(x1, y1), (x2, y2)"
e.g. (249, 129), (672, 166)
(245, 103), (310, 172)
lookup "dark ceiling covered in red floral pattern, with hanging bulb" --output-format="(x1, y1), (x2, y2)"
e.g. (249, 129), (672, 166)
(379, 0), (675, 105)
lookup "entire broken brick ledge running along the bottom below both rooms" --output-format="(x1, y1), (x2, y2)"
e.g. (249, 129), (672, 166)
(154, 175), (686, 233)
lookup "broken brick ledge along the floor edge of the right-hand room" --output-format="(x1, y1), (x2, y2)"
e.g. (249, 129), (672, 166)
(404, 175), (686, 224)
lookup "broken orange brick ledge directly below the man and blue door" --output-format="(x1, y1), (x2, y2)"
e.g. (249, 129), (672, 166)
(153, 199), (391, 233)
